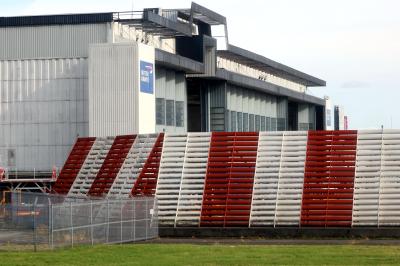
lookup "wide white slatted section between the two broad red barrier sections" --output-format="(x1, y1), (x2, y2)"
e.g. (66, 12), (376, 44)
(250, 131), (307, 226)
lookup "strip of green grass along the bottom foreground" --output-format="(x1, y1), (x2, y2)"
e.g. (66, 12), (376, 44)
(0, 244), (400, 266)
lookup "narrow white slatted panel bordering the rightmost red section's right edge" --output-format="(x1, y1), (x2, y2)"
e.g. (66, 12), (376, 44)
(352, 130), (382, 226)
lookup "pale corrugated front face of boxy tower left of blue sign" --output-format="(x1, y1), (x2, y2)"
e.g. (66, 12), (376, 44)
(89, 43), (139, 136)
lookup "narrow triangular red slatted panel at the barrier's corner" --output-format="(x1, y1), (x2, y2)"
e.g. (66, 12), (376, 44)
(131, 133), (164, 196)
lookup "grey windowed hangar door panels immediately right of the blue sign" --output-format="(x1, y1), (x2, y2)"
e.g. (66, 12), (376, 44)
(155, 67), (187, 133)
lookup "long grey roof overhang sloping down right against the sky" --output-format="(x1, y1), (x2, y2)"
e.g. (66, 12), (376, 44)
(217, 44), (326, 87)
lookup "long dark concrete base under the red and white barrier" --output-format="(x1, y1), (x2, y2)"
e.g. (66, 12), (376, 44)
(159, 227), (400, 238)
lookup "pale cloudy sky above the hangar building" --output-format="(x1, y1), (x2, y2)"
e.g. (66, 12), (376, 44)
(0, 0), (400, 129)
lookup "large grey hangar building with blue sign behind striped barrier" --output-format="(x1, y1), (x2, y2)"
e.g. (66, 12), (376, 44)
(0, 3), (326, 176)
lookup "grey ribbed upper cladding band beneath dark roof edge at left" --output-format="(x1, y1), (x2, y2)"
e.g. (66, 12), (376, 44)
(0, 23), (111, 60)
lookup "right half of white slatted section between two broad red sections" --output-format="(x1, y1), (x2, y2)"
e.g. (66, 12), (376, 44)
(275, 131), (307, 226)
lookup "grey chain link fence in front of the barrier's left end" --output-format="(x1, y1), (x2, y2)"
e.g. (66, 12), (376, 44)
(0, 192), (158, 250)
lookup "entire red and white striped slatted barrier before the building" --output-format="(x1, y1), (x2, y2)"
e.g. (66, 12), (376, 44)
(53, 130), (400, 227)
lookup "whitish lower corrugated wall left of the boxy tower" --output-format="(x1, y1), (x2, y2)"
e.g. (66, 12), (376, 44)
(0, 58), (88, 170)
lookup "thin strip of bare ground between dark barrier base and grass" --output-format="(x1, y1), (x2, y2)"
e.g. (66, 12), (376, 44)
(151, 238), (400, 245)
